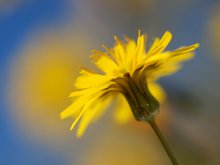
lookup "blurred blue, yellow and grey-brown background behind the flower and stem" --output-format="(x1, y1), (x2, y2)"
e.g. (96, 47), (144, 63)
(0, 0), (220, 165)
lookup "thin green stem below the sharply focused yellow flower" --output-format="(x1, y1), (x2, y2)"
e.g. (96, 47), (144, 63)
(148, 119), (178, 165)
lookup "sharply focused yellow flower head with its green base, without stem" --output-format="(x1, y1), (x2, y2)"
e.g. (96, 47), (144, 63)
(61, 31), (199, 137)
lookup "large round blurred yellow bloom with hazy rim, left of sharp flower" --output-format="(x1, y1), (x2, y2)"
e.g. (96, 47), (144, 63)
(8, 33), (86, 144)
